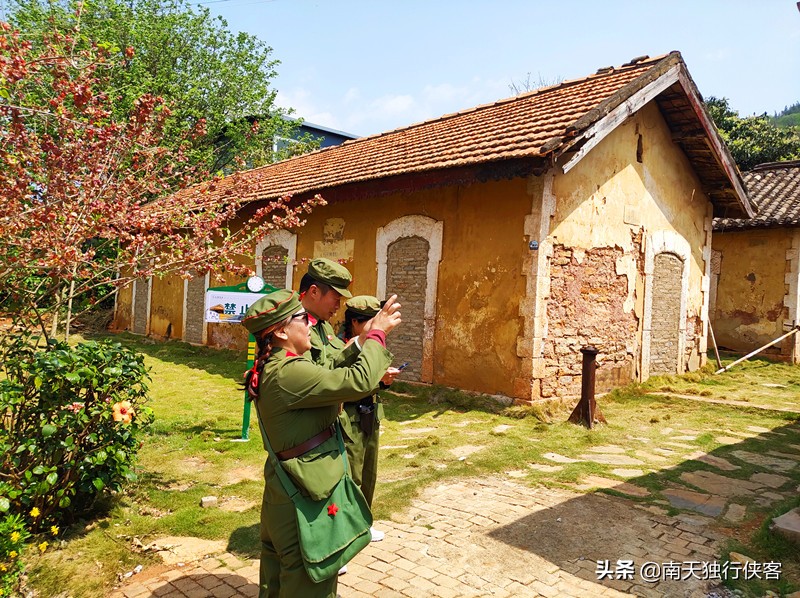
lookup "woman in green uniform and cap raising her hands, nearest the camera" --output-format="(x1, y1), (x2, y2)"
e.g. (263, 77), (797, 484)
(242, 289), (400, 598)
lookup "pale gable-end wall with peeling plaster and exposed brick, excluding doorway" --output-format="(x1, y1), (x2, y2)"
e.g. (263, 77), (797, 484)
(542, 103), (710, 396)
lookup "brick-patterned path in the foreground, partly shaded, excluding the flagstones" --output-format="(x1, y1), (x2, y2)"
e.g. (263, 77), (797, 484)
(111, 478), (718, 598)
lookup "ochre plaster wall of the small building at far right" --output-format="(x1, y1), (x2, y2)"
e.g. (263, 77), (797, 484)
(711, 228), (797, 358)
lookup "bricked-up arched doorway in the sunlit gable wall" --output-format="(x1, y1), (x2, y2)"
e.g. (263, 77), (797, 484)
(650, 253), (680, 374)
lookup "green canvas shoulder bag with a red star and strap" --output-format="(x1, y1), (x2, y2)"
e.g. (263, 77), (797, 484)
(259, 420), (372, 583)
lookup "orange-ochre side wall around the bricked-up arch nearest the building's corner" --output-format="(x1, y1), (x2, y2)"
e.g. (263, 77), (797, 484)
(295, 178), (531, 396)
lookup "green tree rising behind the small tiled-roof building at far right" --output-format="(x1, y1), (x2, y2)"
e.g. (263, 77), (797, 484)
(706, 97), (800, 170)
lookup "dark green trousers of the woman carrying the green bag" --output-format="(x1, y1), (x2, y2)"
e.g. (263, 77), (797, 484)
(258, 492), (338, 598)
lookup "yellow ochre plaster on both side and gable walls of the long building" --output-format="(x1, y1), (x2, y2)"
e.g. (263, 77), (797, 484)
(115, 98), (710, 399)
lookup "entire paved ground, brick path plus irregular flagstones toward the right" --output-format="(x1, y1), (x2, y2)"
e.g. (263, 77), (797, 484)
(111, 400), (800, 598)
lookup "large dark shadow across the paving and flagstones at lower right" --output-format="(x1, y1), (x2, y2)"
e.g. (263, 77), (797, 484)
(488, 405), (800, 596)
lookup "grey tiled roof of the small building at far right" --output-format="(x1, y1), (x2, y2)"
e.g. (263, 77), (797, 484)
(714, 160), (800, 231)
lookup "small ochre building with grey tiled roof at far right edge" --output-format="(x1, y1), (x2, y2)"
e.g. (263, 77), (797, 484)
(711, 161), (800, 363)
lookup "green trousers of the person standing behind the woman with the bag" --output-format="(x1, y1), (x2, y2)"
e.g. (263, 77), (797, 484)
(339, 402), (383, 508)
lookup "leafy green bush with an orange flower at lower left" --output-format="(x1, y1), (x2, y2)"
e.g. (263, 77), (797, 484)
(0, 341), (152, 532)
